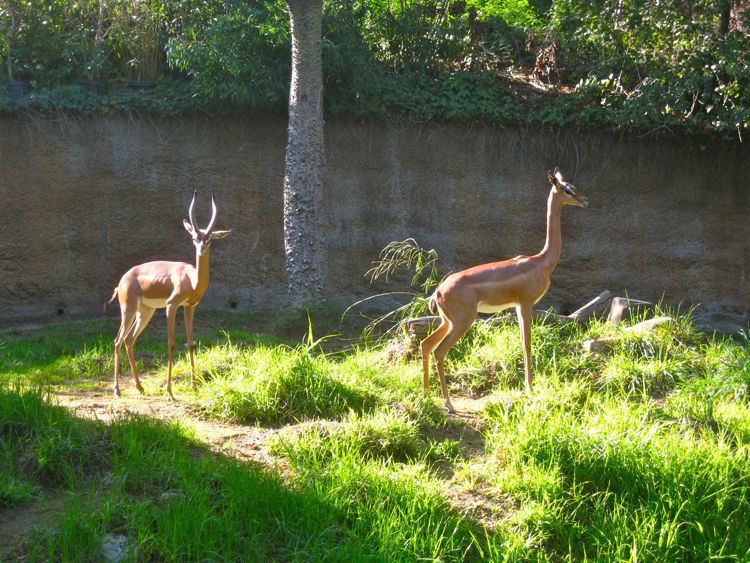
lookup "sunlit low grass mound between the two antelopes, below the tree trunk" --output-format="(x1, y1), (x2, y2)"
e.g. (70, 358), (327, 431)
(191, 334), (432, 424)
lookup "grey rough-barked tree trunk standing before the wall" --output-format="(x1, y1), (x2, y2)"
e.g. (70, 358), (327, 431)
(284, 0), (324, 307)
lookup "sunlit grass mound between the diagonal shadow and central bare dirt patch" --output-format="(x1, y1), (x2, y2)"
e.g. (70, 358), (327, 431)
(275, 411), (496, 561)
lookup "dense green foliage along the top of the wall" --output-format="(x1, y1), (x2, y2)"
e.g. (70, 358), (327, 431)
(0, 0), (750, 139)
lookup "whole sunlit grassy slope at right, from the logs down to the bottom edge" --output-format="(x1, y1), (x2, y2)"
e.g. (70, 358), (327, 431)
(444, 315), (750, 561)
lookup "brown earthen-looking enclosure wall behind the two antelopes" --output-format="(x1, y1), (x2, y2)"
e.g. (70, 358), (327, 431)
(0, 117), (750, 325)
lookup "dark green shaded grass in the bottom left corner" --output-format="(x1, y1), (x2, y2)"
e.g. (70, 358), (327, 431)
(0, 390), (370, 561)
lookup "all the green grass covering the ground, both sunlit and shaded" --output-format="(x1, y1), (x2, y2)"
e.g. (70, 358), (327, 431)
(0, 313), (750, 561)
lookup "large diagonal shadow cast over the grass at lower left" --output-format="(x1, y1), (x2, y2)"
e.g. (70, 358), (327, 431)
(0, 386), (500, 561)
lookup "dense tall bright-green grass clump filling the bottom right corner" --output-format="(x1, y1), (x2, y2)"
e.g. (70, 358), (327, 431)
(481, 398), (750, 560)
